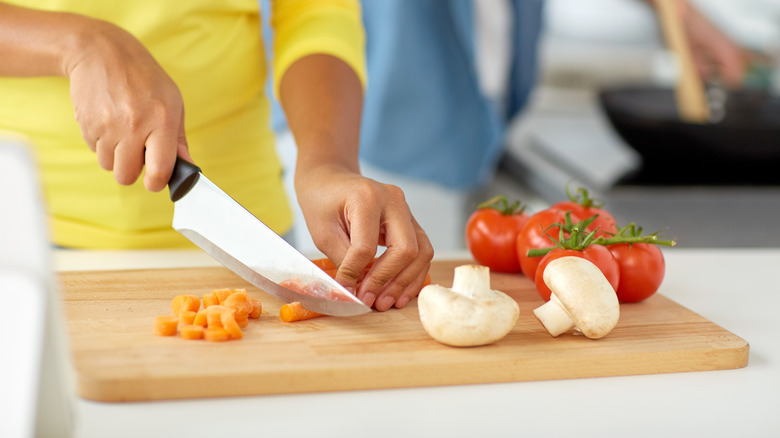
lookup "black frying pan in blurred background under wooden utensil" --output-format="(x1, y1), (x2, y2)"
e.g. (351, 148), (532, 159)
(598, 86), (780, 185)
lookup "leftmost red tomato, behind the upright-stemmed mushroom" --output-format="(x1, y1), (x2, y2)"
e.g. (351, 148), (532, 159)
(466, 207), (529, 272)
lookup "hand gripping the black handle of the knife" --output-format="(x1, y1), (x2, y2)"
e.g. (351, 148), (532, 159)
(65, 22), (191, 192)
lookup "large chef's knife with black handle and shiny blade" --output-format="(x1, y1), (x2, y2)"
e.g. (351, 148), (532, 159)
(168, 158), (371, 316)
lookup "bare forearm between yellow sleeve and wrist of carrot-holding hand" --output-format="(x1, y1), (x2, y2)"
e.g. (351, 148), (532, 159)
(279, 54), (363, 178)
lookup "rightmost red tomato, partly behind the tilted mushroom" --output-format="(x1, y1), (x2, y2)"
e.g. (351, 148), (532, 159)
(606, 243), (666, 303)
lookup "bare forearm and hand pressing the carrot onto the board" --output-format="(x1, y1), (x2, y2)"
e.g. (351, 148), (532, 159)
(279, 54), (433, 311)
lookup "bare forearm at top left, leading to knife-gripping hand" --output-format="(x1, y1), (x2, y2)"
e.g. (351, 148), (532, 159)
(0, 3), (94, 77)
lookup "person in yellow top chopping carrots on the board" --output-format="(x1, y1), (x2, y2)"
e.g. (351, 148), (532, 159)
(0, 0), (433, 311)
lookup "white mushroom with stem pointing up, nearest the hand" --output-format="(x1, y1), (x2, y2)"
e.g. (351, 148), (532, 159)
(417, 265), (520, 347)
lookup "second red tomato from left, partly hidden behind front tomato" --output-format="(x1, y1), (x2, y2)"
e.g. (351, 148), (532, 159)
(516, 209), (580, 280)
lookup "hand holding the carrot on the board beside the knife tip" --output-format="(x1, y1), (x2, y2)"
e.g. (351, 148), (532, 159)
(296, 165), (433, 311)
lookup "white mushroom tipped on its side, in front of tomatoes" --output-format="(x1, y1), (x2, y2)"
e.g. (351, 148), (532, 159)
(534, 257), (620, 339)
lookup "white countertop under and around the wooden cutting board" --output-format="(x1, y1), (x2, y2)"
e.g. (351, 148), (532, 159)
(54, 248), (780, 438)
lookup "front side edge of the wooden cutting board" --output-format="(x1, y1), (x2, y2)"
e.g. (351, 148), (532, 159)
(77, 335), (750, 403)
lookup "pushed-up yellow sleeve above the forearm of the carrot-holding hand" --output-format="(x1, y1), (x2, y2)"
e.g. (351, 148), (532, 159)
(271, 0), (366, 96)
